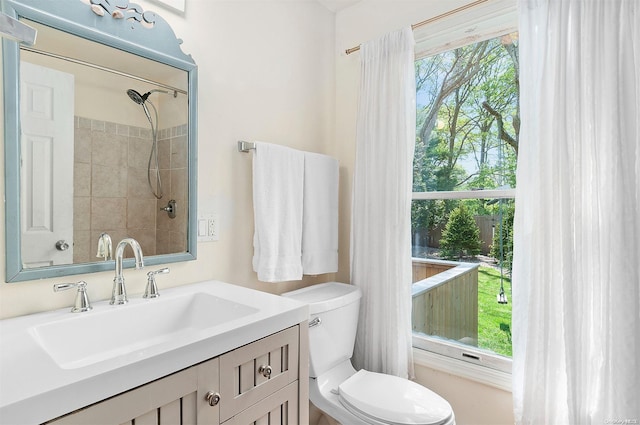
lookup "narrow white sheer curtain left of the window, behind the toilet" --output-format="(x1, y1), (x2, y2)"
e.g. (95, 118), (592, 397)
(351, 28), (416, 377)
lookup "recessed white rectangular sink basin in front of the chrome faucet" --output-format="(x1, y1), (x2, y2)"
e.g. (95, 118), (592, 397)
(30, 292), (258, 369)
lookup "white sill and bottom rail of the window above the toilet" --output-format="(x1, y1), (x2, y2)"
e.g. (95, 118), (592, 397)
(413, 335), (512, 392)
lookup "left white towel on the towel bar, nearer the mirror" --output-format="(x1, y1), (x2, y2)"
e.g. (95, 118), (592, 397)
(253, 142), (304, 282)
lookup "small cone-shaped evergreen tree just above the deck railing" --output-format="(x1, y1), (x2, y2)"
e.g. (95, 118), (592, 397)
(440, 204), (481, 258)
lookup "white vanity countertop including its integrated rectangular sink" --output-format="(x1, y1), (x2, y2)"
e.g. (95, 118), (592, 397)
(0, 281), (309, 424)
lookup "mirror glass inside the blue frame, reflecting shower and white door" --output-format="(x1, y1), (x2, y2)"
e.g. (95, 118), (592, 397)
(20, 21), (189, 268)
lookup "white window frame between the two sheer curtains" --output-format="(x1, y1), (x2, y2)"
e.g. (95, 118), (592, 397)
(411, 0), (518, 380)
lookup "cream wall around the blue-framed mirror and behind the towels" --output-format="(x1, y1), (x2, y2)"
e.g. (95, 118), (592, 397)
(0, 0), (335, 318)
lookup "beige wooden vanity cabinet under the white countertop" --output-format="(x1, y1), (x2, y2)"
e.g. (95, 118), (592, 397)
(48, 322), (308, 425)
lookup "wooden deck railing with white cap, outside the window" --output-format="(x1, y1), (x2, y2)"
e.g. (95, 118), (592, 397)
(412, 258), (478, 345)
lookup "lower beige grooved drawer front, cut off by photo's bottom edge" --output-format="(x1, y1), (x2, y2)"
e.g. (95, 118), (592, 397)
(224, 381), (298, 425)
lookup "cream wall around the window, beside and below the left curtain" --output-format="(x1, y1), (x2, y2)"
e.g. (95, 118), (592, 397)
(332, 0), (514, 425)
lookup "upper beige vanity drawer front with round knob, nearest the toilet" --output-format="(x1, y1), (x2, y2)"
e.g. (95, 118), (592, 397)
(220, 326), (299, 422)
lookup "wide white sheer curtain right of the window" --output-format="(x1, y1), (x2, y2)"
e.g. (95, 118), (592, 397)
(513, 0), (640, 425)
